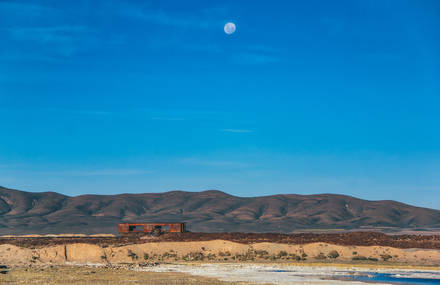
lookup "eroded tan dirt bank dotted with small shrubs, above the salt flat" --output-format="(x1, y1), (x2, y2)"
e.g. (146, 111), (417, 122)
(0, 240), (440, 266)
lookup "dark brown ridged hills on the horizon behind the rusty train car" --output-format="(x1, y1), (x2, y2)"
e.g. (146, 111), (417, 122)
(0, 187), (440, 235)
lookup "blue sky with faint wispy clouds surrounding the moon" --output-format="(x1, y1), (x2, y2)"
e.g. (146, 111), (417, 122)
(0, 0), (440, 209)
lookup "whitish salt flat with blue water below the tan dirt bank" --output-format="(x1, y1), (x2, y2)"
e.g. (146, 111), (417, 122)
(137, 263), (440, 285)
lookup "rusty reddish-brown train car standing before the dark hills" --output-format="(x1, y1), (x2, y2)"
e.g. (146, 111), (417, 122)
(118, 222), (186, 235)
